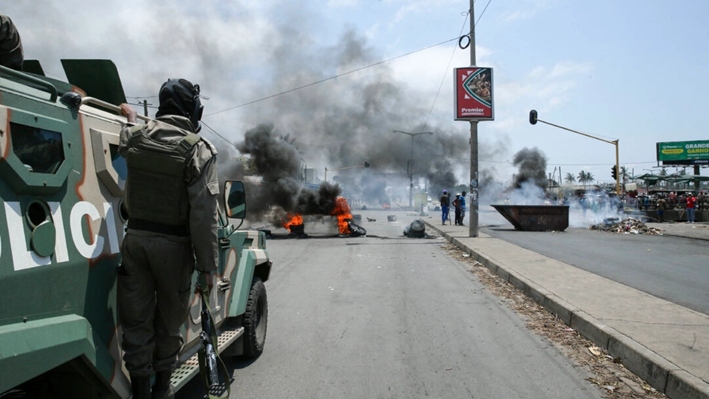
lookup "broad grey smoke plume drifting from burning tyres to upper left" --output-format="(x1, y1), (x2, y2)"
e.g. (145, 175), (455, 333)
(3, 0), (506, 225)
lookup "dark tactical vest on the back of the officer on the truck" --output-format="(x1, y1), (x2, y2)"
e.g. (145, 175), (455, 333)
(125, 122), (200, 236)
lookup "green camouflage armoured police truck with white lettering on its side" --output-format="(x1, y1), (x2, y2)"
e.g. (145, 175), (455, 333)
(0, 60), (271, 399)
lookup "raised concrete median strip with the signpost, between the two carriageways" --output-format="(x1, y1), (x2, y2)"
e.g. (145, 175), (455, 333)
(423, 218), (709, 399)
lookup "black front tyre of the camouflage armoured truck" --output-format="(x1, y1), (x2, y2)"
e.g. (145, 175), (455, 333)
(243, 277), (268, 358)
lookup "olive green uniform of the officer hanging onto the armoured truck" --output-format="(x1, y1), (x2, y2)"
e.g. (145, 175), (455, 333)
(117, 115), (219, 376)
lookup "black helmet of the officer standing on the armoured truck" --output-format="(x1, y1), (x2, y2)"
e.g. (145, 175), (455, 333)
(156, 79), (204, 131)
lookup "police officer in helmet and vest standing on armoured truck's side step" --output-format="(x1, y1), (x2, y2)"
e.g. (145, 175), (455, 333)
(117, 79), (219, 399)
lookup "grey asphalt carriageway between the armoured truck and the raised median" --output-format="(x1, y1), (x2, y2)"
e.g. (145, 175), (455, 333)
(177, 211), (601, 399)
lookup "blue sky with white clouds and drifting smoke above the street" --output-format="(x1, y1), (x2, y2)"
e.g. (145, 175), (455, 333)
(2, 0), (709, 195)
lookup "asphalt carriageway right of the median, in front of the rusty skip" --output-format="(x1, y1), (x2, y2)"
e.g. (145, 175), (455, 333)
(480, 214), (709, 314)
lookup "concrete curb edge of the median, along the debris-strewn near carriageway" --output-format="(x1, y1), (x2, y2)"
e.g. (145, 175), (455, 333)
(426, 222), (709, 399)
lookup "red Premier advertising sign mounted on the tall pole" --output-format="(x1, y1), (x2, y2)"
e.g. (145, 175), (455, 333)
(453, 67), (495, 121)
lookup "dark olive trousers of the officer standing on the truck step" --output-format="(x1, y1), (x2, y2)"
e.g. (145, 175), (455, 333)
(117, 231), (194, 376)
